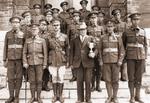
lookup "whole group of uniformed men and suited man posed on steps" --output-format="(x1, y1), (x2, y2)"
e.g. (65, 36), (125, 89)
(3, 0), (147, 103)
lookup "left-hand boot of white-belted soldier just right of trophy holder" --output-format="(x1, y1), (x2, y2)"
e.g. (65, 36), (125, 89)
(105, 82), (112, 103)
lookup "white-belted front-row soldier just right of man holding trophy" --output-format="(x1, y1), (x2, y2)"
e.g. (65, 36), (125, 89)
(99, 20), (125, 103)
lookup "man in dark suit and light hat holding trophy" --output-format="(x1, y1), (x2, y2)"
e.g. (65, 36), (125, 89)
(70, 22), (97, 103)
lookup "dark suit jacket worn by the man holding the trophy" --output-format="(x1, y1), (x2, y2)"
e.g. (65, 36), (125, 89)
(69, 36), (97, 68)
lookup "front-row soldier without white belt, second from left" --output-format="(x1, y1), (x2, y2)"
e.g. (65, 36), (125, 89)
(23, 23), (47, 103)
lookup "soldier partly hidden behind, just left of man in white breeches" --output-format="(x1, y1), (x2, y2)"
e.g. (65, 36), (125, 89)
(39, 19), (51, 91)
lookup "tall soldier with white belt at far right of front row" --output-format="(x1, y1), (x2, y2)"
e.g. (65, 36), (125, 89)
(123, 13), (147, 103)
